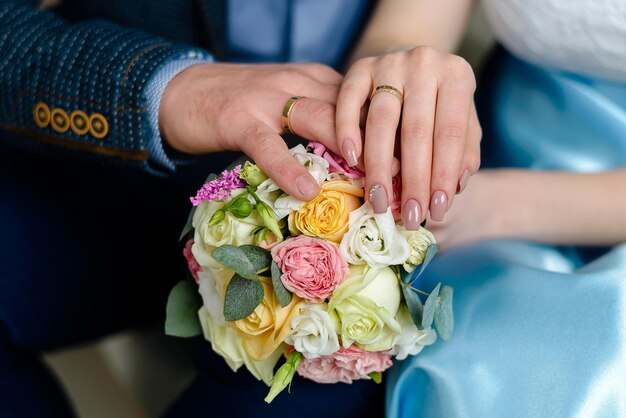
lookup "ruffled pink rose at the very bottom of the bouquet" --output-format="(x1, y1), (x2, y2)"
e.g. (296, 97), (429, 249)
(298, 344), (393, 383)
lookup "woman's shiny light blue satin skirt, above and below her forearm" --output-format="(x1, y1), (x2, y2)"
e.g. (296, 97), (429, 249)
(386, 51), (626, 418)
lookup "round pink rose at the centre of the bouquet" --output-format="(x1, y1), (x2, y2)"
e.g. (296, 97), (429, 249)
(272, 235), (350, 302)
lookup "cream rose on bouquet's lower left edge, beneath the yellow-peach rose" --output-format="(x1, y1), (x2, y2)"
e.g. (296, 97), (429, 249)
(198, 307), (284, 386)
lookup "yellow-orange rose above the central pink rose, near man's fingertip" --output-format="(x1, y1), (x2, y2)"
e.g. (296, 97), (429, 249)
(289, 180), (363, 243)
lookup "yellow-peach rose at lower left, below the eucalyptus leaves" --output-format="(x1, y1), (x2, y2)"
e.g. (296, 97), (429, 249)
(232, 277), (303, 360)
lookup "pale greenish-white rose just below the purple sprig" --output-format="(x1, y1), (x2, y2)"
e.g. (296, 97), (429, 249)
(191, 196), (263, 268)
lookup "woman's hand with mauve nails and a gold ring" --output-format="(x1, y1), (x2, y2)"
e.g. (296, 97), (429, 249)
(336, 47), (482, 229)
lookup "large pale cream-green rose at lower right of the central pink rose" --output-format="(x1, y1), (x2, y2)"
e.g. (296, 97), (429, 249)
(328, 265), (402, 351)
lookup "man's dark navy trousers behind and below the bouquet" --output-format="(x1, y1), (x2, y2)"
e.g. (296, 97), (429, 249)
(0, 145), (383, 418)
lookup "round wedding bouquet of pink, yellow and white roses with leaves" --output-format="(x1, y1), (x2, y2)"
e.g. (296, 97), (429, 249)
(166, 143), (453, 402)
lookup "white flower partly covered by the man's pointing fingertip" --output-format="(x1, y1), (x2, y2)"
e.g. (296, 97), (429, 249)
(256, 144), (328, 219)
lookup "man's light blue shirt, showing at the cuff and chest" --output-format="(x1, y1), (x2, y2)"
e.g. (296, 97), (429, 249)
(146, 0), (371, 169)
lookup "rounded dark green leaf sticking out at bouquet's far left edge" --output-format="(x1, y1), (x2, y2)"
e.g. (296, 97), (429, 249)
(165, 280), (202, 338)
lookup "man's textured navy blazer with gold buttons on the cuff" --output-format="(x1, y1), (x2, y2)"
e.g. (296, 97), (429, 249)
(0, 0), (226, 171)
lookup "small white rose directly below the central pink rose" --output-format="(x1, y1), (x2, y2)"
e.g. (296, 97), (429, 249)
(285, 303), (339, 359)
